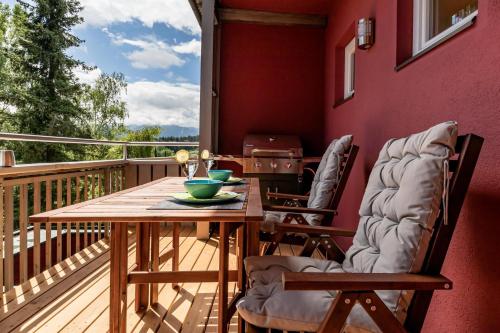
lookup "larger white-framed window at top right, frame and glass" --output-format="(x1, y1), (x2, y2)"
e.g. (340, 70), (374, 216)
(413, 0), (478, 55)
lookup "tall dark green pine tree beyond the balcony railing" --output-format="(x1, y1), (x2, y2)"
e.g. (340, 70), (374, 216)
(12, 0), (88, 162)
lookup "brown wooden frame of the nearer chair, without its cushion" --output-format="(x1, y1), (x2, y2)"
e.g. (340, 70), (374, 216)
(242, 134), (483, 333)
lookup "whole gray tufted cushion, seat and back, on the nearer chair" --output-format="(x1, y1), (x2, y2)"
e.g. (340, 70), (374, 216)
(237, 122), (457, 331)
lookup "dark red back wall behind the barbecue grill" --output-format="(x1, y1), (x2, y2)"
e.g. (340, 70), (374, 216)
(219, 23), (324, 154)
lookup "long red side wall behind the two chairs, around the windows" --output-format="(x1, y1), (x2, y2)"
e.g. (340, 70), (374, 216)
(324, 0), (500, 332)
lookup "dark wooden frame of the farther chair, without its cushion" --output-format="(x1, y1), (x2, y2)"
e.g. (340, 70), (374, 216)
(261, 145), (359, 256)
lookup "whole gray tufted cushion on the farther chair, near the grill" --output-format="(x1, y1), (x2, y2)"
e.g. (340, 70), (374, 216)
(261, 135), (352, 232)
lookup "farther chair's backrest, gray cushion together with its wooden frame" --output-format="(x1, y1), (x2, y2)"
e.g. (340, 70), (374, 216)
(305, 135), (358, 225)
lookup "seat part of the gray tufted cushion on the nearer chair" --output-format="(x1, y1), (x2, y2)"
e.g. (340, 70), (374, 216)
(237, 256), (378, 332)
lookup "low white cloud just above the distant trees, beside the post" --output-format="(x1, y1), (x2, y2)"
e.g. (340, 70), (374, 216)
(124, 81), (200, 127)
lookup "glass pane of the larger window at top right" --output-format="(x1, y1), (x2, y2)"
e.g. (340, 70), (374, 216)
(428, 0), (477, 39)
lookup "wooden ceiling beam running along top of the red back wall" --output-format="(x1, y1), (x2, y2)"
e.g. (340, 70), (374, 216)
(218, 8), (328, 27)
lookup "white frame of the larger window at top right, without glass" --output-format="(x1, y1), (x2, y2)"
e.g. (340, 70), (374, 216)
(413, 0), (478, 55)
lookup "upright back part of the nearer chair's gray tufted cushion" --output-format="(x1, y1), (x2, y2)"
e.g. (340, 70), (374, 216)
(342, 122), (458, 322)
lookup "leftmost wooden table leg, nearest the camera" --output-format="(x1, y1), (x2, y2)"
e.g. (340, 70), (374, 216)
(109, 223), (128, 333)
